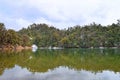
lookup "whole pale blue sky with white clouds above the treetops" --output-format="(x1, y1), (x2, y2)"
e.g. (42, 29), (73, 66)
(0, 0), (120, 30)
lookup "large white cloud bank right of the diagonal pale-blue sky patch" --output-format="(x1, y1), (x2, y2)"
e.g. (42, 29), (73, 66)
(27, 0), (120, 27)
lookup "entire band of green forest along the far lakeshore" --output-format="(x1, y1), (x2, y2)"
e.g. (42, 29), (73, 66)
(0, 20), (120, 48)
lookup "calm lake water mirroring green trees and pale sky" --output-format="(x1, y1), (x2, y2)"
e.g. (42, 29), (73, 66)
(0, 49), (120, 80)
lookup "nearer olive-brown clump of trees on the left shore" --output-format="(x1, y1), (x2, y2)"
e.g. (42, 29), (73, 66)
(0, 23), (31, 48)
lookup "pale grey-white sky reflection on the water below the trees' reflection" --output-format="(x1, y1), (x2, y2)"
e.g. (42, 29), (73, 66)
(0, 66), (120, 80)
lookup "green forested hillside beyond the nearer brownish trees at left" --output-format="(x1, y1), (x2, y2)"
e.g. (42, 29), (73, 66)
(18, 20), (120, 48)
